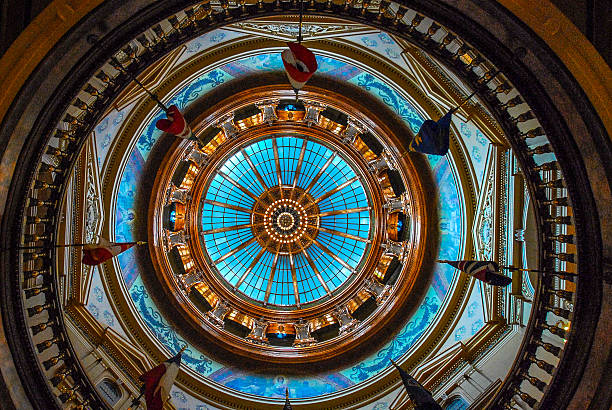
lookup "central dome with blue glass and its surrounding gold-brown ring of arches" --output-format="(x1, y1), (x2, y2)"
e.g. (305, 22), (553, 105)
(150, 89), (433, 373)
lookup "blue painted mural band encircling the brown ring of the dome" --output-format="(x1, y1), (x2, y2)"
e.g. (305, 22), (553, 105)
(115, 48), (463, 400)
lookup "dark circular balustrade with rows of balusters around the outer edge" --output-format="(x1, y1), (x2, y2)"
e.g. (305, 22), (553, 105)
(13, 0), (578, 408)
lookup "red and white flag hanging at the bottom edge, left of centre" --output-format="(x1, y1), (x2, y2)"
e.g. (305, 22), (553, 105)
(138, 346), (186, 410)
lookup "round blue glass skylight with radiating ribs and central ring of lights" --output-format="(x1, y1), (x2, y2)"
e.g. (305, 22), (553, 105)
(201, 136), (372, 309)
